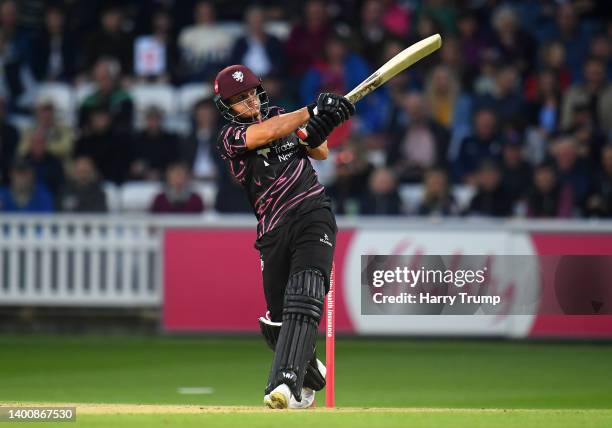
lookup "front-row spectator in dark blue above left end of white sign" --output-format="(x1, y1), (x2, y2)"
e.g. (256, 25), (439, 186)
(359, 168), (402, 215)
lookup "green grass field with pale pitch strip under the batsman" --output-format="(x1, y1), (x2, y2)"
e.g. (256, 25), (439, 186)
(0, 336), (612, 428)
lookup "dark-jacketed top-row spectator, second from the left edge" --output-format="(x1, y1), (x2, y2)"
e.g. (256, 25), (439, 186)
(32, 5), (78, 82)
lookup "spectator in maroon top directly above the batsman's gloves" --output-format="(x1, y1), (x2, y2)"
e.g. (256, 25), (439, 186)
(285, 0), (333, 77)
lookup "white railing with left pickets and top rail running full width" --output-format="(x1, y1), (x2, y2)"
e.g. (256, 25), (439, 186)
(0, 214), (612, 307)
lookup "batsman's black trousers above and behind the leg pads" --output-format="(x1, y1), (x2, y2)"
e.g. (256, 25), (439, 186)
(255, 208), (338, 322)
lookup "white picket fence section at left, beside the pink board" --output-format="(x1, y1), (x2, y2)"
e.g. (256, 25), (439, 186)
(0, 216), (162, 306)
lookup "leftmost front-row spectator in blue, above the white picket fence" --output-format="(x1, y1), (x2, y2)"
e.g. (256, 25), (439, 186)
(0, 160), (53, 213)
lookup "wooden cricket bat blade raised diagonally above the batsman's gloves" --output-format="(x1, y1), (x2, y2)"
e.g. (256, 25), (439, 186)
(296, 34), (442, 140)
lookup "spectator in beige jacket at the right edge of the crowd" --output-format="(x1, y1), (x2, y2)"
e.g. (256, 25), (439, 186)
(561, 58), (612, 133)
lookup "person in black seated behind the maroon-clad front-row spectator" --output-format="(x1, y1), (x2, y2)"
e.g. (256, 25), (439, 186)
(130, 107), (179, 181)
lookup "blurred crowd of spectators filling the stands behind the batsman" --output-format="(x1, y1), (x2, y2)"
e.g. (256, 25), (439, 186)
(0, 0), (612, 218)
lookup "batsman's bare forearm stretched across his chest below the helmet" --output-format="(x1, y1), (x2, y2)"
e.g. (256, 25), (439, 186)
(246, 107), (311, 150)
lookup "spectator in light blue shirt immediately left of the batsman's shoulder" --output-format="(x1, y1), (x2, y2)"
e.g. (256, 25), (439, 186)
(181, 98), (219, 181)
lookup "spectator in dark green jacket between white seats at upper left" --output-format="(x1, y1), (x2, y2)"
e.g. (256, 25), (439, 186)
(79, 59), (134, 133)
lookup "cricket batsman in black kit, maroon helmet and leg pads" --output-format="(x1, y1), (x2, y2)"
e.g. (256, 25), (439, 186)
(214, 65), (355, 409)
